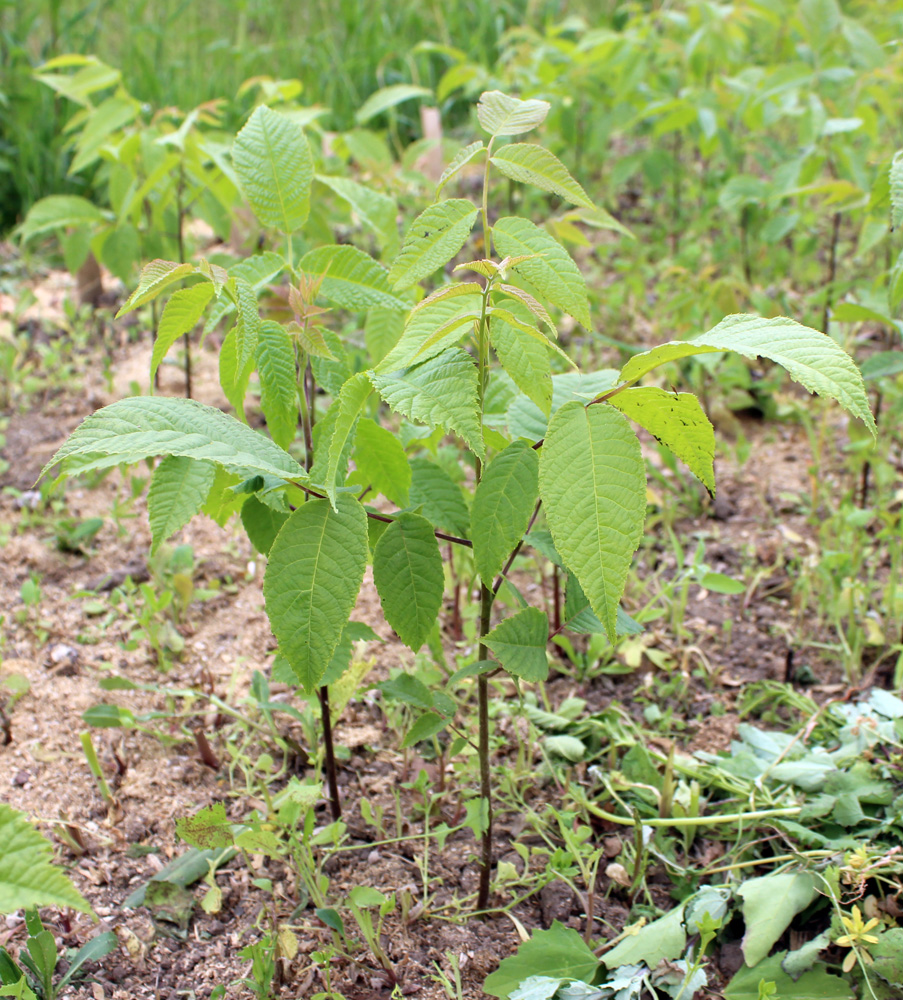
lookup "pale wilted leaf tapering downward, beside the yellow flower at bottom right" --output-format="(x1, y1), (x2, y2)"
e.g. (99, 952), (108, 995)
(737, 872), (818, 966)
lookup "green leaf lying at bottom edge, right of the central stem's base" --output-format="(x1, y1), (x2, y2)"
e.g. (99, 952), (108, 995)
(483, 920), (599, 1000)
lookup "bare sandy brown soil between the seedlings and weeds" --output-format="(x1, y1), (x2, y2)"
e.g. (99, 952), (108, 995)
(0, 266), (868, 1000)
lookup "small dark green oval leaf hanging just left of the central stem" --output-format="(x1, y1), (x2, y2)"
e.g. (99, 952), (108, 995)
(373, 512), (445, 653)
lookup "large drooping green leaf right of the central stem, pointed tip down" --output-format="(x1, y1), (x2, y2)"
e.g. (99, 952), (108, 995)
(539, 402), (646, 643)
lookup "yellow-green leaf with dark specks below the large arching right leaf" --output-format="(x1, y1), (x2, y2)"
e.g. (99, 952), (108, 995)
(609, 386), (715, 496)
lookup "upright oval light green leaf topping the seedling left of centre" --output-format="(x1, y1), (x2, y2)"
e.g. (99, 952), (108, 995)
(232, 105), (314, 233)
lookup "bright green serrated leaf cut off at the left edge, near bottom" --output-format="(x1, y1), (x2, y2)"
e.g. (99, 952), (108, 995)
(0, 802), (92, 913)
